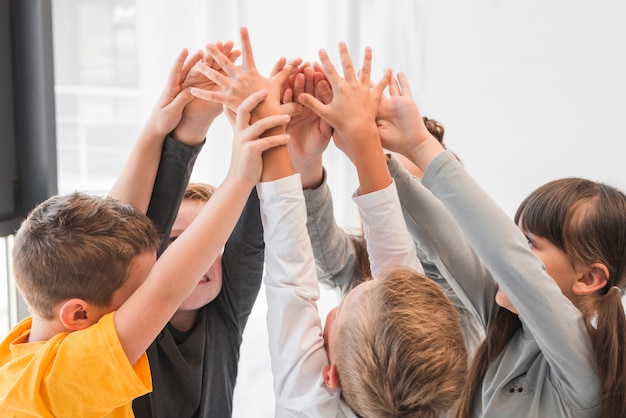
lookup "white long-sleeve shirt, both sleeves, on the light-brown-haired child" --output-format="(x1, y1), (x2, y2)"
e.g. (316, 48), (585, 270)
(257, 175), (423, 418)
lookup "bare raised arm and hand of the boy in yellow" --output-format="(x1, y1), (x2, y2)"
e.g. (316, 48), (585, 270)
(115, 91), (288, 363)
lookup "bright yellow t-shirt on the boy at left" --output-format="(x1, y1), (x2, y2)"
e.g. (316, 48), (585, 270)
(0, 312), (152, 418)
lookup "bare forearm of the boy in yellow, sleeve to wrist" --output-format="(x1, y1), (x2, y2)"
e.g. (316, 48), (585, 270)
(116, 177), (253, 362)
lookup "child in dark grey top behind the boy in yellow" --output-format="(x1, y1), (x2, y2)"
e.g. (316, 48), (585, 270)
(133, 42), (264, 418)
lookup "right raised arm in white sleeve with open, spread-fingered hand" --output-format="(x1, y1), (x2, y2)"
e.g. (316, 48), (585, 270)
(299, 43), (423, 277)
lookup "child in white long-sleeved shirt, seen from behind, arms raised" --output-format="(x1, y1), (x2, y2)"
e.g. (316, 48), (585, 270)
(200, 35), (466, 417)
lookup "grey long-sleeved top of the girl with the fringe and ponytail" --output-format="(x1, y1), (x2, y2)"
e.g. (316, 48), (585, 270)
(414, 152), (601, 418)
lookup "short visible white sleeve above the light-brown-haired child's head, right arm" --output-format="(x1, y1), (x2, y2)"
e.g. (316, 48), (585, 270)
(352, 181), (424, 278)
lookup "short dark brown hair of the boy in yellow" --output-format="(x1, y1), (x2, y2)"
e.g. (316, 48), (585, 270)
(13, 192), (159, 319)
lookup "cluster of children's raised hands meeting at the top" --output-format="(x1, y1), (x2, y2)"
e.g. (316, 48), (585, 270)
(146, 27), (436, 188)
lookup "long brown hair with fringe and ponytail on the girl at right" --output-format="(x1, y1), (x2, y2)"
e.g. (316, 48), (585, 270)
(458, 178), (626, 417)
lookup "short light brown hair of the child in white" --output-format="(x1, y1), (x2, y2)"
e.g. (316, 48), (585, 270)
(336, 268), (467, 418)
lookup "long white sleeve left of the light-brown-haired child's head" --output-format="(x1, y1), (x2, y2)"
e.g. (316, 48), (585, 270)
(257, 175), (339, 417)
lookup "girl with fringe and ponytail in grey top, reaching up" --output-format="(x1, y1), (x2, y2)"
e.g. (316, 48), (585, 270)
(382, 72), (626, 417)
